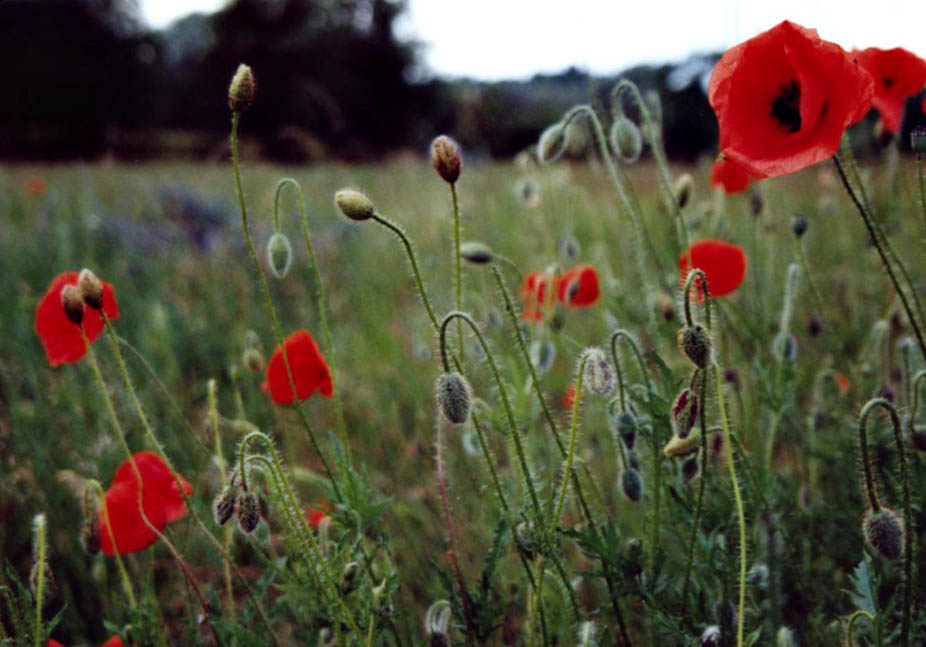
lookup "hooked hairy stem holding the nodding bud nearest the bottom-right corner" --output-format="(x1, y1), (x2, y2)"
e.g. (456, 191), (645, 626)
(858, 398), (913, 647)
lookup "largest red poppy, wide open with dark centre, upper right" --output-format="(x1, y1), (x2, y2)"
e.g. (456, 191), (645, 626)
(708, 20), (873, 178)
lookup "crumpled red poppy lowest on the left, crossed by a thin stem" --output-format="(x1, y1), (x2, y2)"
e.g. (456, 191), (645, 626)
(98, 451), (193, 555)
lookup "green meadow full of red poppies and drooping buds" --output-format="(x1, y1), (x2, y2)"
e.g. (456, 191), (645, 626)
(0, 17), (926, 647)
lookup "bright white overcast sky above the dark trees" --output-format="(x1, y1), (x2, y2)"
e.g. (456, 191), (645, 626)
(141, 0), (926, 79)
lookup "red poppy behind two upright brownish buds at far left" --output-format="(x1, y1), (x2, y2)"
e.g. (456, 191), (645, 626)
(35, 272), (119, 366)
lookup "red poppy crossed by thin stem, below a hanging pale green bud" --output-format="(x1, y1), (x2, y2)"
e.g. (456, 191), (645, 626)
(261, 330), (334, 404)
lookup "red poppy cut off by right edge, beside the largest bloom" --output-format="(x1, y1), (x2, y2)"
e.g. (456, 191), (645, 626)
(852, 47), (926, 133)
